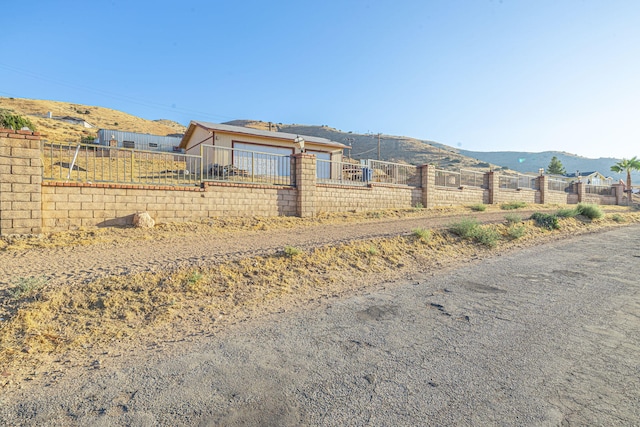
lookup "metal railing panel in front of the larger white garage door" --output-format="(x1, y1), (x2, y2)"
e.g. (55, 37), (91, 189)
(200, 145), (295, 185)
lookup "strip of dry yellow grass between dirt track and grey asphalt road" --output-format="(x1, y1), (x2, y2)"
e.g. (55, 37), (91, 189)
(0, 213), (640, 385)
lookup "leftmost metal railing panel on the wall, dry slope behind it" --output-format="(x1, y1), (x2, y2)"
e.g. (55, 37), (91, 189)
(42, 141), (200, 185)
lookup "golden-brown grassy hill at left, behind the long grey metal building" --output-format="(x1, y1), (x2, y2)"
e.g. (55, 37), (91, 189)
(0, 97), (186, 142)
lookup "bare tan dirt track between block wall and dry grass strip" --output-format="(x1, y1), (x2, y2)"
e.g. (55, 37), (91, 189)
(0, 211), (532, 288)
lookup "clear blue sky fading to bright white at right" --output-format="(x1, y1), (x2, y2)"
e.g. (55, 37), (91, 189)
(0, 0), (640, 158)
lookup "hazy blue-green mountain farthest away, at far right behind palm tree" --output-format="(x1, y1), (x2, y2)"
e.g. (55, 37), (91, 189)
(456, 150), (640, 182)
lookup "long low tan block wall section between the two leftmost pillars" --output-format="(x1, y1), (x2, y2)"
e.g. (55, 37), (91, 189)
(42, 182), (297, 231)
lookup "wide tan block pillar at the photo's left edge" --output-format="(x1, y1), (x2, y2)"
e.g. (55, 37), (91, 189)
(0, 129), (42, 236)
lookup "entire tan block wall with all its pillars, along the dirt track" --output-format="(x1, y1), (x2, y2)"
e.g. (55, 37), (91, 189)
(0, 129), (621, 235)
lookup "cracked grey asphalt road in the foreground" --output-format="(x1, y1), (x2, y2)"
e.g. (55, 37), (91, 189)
(0, 225), (640, 426)
